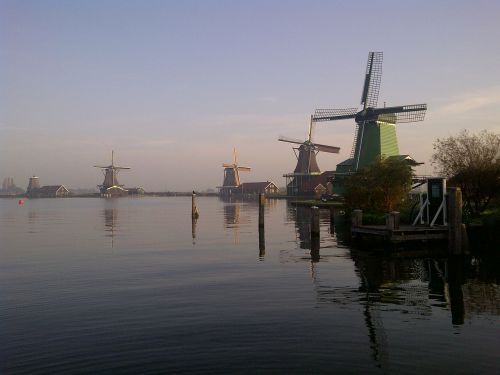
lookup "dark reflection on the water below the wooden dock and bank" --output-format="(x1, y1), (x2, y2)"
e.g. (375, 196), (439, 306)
(313, 250), (500, 367)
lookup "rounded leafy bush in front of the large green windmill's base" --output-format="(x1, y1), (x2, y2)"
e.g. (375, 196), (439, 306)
(345, 158), (412, 212)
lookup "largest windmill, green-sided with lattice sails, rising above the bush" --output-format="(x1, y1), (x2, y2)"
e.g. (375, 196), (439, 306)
(313, 52), (427, 173)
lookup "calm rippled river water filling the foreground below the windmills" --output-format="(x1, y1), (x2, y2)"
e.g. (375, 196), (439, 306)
(0, 197), (500, 374)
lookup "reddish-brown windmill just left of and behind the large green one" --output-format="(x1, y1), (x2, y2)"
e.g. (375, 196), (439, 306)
(278, 116), (340, 195)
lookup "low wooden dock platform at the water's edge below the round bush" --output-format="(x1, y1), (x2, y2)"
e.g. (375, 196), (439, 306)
(351, 225), (448, 242)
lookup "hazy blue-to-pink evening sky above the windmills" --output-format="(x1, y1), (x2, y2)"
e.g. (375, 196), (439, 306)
(0, 0), (500, 191)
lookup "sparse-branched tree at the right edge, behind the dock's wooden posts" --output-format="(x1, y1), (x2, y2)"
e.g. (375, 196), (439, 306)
(432, 130), (500, 216)
